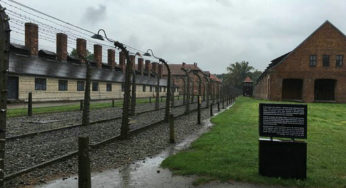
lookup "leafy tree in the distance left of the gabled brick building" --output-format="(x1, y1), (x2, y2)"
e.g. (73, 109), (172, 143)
(224, 61), (262, 89)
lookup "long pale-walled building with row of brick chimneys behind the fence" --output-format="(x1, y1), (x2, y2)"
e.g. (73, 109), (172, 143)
(8, 23), (174, 101)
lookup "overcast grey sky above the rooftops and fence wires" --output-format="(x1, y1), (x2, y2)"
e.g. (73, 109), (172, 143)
(9, 0), (346, 73)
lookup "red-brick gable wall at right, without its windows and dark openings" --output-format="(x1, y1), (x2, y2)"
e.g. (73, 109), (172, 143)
(254, 22), (346, 102)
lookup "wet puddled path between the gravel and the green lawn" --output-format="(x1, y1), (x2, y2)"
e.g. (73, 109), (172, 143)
(36, 105), (274, 188)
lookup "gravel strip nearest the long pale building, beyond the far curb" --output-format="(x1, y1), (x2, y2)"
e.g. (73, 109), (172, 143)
(6, 100), (187, 137)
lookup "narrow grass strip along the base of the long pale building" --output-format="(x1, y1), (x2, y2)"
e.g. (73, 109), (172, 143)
(7, 98), (172, 117)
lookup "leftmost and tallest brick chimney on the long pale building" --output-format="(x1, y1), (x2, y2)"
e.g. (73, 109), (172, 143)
(25, 23), (38, 56)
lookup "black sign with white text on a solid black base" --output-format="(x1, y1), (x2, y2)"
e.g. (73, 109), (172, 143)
(259, 103), (307, 179)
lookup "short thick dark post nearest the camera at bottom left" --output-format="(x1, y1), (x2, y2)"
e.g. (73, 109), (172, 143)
(78, 136), (91, 188)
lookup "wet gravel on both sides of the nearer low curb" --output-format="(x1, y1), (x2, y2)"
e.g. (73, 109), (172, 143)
(6, 100), (224, 187)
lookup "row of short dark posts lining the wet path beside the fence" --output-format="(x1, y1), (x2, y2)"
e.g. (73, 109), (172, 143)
(78, 96), (234, 188)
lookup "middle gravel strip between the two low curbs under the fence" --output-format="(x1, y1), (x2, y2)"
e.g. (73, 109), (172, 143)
(5, 100), (208, 174)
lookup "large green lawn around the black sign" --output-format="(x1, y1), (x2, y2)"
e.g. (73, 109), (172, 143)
(161, 97), (346, 187)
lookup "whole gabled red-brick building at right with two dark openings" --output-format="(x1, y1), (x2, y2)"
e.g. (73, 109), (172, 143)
(254, 21), (346, 103)
